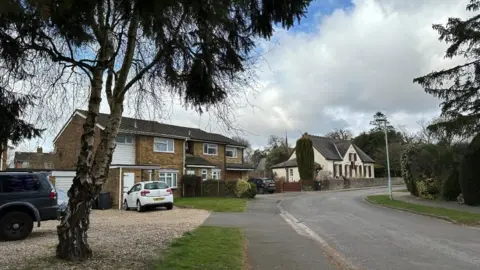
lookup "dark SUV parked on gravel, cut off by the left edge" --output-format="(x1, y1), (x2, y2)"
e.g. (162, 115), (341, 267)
(0, 172), (58, 240)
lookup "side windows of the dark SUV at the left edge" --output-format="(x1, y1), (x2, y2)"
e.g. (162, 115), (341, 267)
(0, 174), (41, 193)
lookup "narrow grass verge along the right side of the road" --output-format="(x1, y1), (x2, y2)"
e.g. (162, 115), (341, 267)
(367, 195), (480, 225)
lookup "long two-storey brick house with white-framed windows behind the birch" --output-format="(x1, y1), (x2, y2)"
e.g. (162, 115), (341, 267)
(53, 110), (253, 208)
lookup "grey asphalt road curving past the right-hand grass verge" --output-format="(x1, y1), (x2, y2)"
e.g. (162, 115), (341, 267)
(282, 189), (480, 270)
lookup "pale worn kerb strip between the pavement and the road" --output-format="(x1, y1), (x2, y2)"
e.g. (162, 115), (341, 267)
(277, 198), (361, 270)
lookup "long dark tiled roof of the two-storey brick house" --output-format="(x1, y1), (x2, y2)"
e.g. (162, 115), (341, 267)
(54, 110), (244, 147)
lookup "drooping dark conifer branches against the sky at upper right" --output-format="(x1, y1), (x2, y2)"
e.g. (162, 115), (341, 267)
(413, 0), (480, 137)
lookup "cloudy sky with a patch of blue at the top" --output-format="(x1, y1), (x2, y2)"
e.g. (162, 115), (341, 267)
(19, 0), (471, 151)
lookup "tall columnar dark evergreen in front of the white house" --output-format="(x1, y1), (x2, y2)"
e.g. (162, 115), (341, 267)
(295, 133), (315, 180)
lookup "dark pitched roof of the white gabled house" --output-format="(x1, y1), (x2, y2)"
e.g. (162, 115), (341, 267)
(309, 135), (375, 163)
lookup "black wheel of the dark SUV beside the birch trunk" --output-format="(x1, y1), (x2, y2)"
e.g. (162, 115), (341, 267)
(0, 212), (33, 241)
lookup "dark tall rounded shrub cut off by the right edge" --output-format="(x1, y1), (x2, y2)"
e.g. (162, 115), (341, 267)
(459, 135), (480, 205)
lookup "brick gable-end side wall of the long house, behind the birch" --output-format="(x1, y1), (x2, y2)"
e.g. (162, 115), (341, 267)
(53, 115), (101, 169)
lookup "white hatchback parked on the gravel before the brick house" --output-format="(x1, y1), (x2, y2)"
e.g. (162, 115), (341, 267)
(123, 181), (173, 212)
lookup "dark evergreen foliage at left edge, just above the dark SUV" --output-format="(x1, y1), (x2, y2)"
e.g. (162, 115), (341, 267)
(0, 87), (44, 157)
